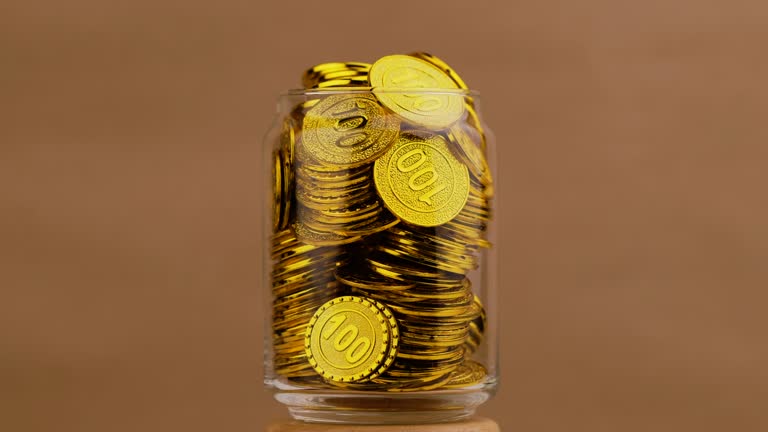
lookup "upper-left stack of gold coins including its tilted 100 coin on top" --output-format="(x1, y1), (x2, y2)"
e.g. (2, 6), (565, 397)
(295, 94), (400, 245)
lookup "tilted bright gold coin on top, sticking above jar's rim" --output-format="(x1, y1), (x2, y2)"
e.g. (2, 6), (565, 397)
(369, 55), (465, 129)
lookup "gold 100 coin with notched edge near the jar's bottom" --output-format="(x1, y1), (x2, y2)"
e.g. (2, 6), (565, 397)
(304, 296), (399, 382)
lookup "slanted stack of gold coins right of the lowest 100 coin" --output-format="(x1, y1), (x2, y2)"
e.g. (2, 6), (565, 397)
(336, 260), (479, 391)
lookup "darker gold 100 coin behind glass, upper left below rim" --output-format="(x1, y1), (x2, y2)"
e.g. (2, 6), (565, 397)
(302, 94), (400, 168)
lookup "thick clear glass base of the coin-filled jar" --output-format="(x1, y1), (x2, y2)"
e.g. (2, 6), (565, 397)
(275, 389), (490, 425)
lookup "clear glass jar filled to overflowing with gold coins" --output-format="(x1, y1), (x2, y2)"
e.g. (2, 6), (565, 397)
(262, 87), (498, 424)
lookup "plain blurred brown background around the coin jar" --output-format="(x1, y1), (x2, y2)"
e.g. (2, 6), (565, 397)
(0, 0), (768, 432)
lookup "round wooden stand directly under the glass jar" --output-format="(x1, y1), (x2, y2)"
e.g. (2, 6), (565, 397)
(267, 417), (500, 432)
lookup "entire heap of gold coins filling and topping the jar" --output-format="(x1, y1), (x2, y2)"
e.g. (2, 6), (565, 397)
(271, 53), (493, 391)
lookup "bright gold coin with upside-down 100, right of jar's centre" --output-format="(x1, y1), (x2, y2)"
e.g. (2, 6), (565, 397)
(374, 132), (469, 226)
